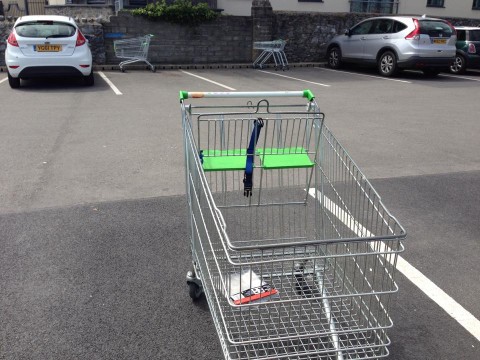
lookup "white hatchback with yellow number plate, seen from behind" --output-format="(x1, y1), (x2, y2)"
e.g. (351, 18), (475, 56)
(5, 15), (94, 88)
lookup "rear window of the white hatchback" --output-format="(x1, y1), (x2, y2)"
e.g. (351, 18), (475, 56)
(15, 21), (76, 38)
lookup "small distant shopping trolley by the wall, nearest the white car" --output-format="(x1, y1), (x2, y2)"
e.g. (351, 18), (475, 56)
(113, 34), (156, 72)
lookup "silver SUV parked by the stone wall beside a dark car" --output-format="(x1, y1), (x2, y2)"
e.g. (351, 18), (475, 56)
(327, 16), (457, 76)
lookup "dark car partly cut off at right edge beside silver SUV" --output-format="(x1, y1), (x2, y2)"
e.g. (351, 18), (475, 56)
(450, 26), (480, 74)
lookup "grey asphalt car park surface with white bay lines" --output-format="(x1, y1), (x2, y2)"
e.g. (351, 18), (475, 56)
(0, 66), (480, 360)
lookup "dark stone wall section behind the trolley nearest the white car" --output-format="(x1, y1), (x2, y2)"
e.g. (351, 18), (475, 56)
(103, 12), (252, 64)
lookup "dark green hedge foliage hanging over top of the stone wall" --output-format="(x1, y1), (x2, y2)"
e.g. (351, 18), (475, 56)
(130, 0), (219, 25)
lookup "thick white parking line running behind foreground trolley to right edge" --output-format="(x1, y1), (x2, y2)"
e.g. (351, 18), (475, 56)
(308, 188), (480, 341)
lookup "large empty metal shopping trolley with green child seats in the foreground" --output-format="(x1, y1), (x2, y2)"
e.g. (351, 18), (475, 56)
(180, 90), (406, 360)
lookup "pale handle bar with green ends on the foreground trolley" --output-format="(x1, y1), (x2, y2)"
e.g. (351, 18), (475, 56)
(180, 89), (315, 101)
